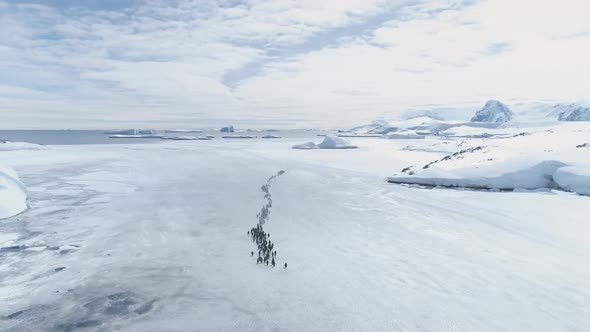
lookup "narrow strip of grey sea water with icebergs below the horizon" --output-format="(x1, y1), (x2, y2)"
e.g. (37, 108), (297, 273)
(0, 129), (327, 145)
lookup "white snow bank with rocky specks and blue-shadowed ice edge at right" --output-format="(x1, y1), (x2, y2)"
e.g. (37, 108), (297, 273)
(388, 120), (590, 194)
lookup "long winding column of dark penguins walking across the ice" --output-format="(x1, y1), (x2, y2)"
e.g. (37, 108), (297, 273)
(248, 170), (287, 268)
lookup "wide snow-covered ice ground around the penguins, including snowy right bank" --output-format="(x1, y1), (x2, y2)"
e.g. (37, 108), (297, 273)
(0, 126), (590, 331)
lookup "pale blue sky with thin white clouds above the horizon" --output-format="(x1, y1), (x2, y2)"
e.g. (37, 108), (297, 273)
(0, 0), (590, 129)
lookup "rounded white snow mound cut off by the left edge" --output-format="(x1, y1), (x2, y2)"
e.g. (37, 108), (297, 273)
(0, 165), (27, 219)
